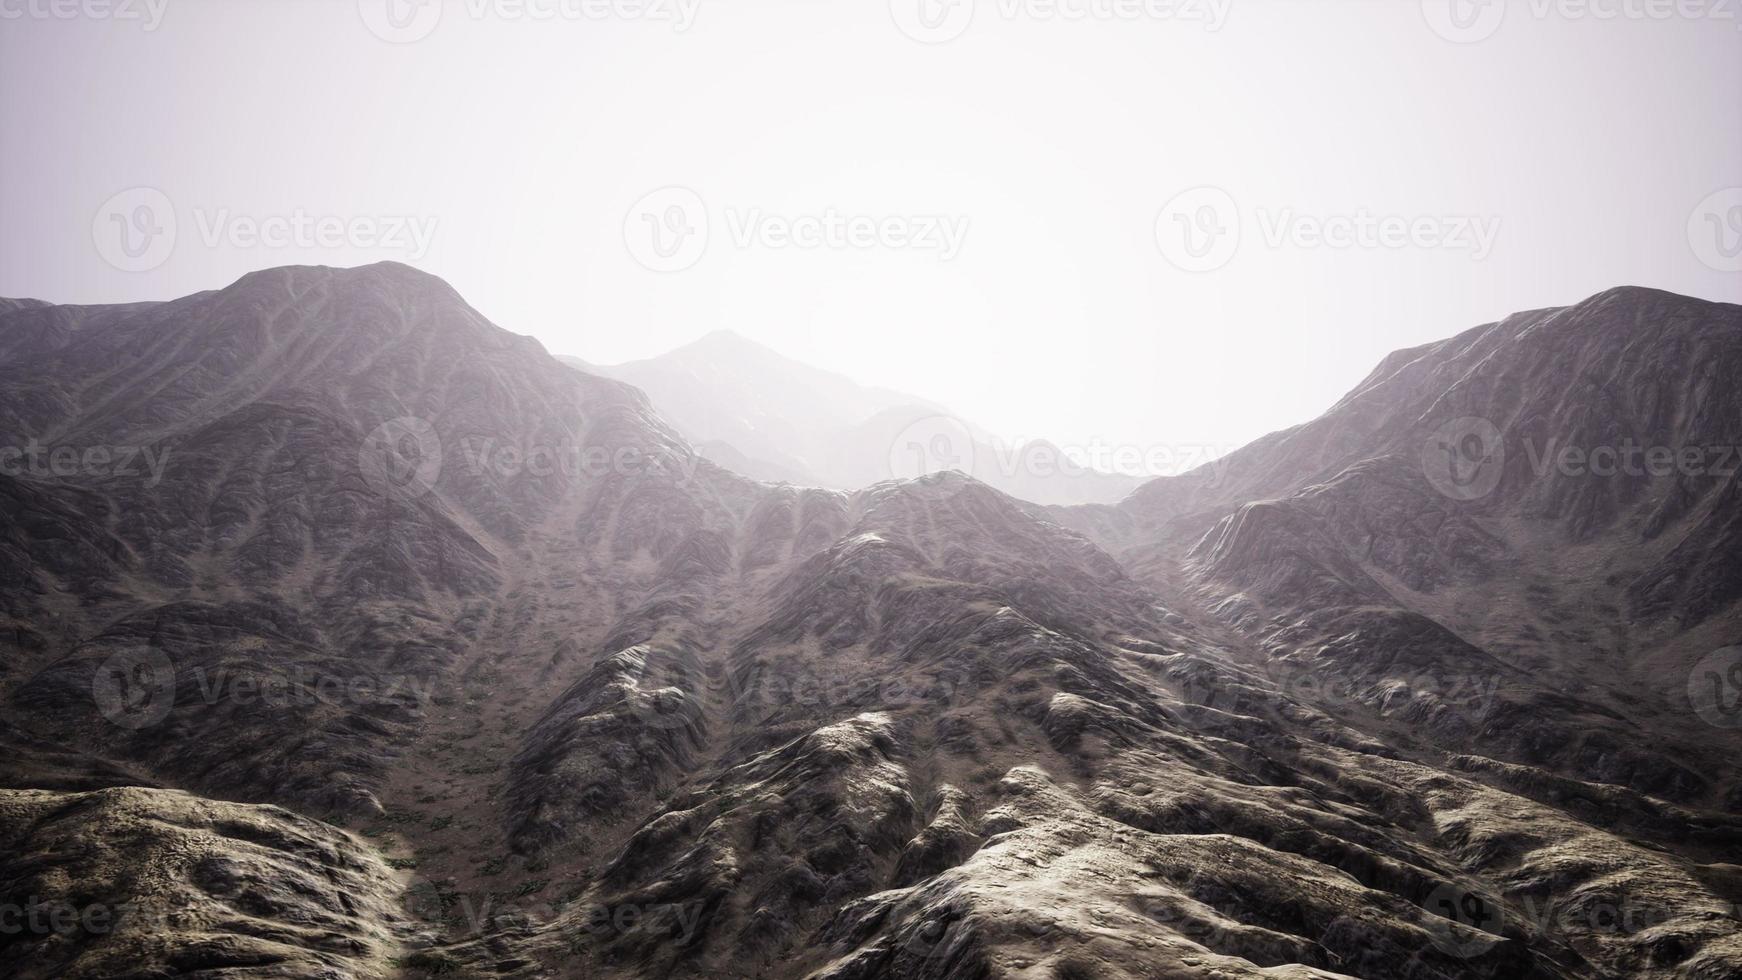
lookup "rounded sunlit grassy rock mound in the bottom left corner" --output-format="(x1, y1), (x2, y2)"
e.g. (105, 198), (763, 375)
(0, 787), (402, 978)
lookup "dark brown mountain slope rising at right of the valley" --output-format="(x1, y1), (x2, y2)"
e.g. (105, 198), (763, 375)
(1066, 289), (1742, 808)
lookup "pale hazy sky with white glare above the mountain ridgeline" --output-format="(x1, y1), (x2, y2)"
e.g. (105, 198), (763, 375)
(0, 0), (1742, 466)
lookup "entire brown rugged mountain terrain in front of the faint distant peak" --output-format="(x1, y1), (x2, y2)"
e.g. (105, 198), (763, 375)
(0, 266), (1742, 980)
